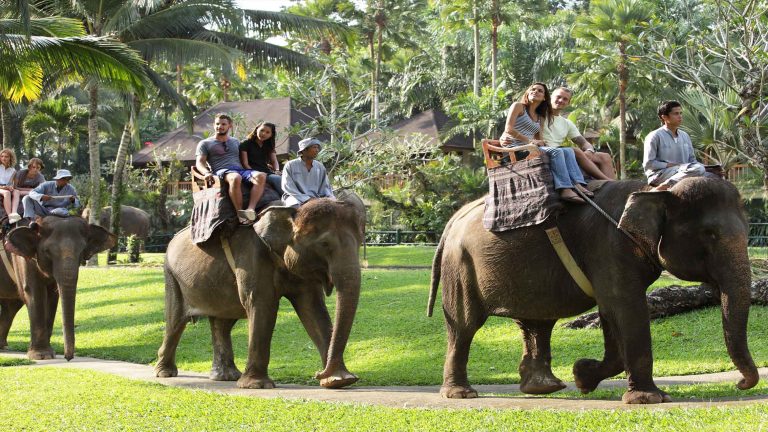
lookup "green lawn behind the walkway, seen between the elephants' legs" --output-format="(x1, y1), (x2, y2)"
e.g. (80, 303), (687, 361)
(3, 268), (768, 385)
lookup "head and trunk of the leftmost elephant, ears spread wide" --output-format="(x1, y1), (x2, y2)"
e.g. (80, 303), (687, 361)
(6, 216), (117, 360)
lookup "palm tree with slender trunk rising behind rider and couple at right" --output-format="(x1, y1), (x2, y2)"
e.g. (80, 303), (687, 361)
(566, 0), (653, 178)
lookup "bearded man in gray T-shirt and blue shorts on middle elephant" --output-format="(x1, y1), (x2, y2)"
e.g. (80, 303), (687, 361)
(195, 114), (267, 222)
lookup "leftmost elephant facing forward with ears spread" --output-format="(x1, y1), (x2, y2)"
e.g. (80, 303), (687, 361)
(0, 216), (117, 360)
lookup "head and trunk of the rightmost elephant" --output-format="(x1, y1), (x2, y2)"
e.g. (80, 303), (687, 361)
(619, 178), (759, 389)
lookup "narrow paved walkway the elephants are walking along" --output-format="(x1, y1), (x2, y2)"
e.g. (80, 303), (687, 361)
(0, 351), (768, 410)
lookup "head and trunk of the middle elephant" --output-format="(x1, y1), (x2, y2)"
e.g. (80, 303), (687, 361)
(262, 198), (365, 387)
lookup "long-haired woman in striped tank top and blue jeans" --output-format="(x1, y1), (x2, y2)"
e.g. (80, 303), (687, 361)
(500, 82), (592, 203)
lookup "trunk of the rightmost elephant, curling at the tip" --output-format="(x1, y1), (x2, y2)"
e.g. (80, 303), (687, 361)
(718, 248), (760, 390)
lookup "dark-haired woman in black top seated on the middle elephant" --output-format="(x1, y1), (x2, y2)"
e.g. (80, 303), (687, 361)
(240, 122), (283, 196)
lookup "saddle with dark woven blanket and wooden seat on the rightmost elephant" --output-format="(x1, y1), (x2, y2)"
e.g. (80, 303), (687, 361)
(482, 139), (562, 232)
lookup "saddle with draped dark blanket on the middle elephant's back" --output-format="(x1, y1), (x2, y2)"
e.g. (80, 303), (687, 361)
(190, 166), (280, 244)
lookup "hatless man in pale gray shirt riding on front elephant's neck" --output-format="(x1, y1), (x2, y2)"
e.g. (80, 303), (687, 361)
(643, 100), (718, 191)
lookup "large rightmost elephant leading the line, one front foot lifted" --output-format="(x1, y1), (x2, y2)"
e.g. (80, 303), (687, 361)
(427, 178), (759, 403)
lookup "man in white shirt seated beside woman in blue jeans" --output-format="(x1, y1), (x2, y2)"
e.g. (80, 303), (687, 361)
(541, 87), (616, 180)
